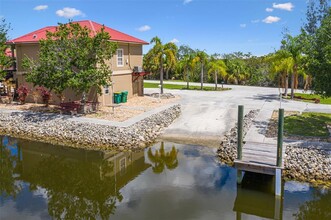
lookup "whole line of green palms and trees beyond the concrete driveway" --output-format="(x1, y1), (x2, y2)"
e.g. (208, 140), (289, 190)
(144, 0), (331, 98)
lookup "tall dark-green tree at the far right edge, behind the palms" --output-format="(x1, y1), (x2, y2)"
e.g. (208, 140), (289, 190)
(308, 8), (331, 96)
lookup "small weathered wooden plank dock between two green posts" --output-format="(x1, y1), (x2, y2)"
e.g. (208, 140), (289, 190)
(234, 142), (285, 175)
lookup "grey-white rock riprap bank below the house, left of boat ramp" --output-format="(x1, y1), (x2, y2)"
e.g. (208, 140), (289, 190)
(0, 105), (181, 150)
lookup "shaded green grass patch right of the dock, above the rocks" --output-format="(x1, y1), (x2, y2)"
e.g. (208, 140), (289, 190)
(284, 112), (331, 138)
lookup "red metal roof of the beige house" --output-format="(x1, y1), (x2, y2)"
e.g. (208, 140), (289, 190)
(7, 20), (148, 44)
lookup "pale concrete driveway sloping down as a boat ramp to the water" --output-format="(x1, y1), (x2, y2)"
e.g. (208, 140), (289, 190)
(145, 80), (331, 146)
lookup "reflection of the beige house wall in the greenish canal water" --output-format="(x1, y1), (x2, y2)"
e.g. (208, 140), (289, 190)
(18, 140), (150, 190)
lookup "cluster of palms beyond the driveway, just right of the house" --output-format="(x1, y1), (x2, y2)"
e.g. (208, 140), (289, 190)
(144, 37), (256, 93)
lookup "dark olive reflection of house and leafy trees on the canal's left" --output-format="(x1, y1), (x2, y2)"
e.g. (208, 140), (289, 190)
(1, 137), (150, 219)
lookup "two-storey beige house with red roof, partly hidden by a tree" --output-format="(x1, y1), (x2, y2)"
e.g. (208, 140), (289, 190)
(7, 20), (148, 105)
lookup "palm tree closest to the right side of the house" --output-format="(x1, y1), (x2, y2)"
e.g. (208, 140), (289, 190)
(147, 36), (177, 94)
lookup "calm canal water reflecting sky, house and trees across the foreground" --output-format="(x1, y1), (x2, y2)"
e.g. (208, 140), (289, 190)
(0, 137), (331, 220)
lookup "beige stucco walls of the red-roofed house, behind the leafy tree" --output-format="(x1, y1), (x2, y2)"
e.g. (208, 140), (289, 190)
(15, 43), (143, 105)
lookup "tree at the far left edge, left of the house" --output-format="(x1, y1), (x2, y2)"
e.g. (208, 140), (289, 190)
(0, 19), (13, 79)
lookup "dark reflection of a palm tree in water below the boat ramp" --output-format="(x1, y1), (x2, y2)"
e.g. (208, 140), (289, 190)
(148, 142), (178, 173)
